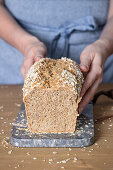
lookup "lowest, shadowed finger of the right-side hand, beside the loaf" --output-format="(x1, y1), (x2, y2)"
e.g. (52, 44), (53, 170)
(78, 80), (100, 114)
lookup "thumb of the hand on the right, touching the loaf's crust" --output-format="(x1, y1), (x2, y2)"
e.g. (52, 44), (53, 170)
(80, 53), (94, 72)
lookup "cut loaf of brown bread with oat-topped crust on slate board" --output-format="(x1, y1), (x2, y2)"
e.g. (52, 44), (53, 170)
(23, 57), (83, 133)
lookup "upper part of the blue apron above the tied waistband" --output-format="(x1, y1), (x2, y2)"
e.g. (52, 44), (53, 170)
(5, 0), (109, 28)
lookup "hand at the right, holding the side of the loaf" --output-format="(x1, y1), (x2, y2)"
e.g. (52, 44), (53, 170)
(79, 40), (107, 114)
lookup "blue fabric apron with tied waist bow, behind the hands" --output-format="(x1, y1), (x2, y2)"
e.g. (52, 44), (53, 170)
(0, 0), (113, 84)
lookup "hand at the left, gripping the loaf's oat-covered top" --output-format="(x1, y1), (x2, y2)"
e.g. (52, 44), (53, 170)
(21, 38), (47, 79)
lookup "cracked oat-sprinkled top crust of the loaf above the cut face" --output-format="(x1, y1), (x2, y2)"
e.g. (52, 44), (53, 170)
(22, 57), (84, 99)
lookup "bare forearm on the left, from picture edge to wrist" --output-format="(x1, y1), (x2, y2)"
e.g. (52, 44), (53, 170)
(0, 3), (38, 53)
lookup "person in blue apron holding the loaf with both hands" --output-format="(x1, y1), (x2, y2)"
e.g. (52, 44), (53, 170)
(0, 0), (113, 113)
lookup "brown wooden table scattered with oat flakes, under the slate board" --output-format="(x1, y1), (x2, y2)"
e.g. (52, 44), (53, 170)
(0, 84), (113, 170)
